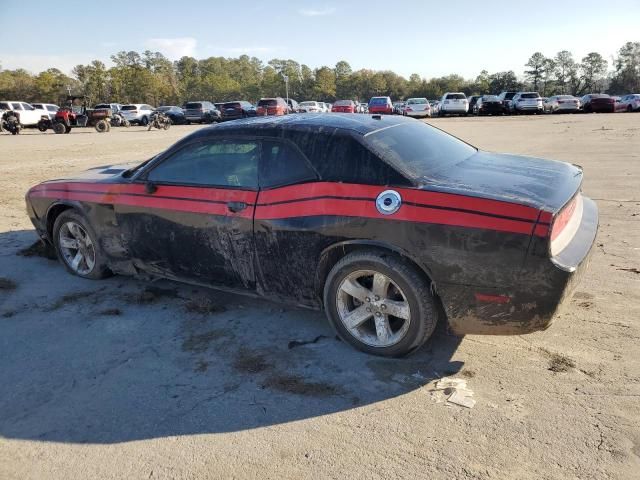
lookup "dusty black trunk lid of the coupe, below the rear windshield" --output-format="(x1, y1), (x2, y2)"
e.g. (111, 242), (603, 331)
(424, 151), (582, 212)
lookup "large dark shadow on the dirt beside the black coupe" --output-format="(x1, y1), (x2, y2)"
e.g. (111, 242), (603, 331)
(0, 231), (463, 443)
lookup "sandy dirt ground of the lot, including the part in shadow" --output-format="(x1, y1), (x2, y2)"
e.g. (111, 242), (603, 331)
(0, 114), (640, 480)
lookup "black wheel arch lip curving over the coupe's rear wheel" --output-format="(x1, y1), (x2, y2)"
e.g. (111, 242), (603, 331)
(314, 239), (440, 301)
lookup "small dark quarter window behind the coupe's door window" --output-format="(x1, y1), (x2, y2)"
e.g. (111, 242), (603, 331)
(260, 140), (318, 188)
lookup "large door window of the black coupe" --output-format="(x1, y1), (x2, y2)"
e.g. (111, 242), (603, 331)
(147, 140), (260, 188)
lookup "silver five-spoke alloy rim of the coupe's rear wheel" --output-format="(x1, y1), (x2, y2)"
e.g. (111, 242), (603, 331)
(336, 270), (411, 348)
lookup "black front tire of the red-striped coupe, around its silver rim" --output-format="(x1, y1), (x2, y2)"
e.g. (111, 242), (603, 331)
(53, 210), (111, 280)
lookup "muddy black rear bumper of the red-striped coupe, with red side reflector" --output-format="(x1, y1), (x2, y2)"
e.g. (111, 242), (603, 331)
(440, 197), (598, 335)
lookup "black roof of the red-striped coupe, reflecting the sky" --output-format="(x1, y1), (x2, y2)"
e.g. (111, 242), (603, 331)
(185, 113), (415, 138)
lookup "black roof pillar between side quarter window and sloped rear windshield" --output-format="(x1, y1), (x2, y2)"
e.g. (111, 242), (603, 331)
(288, 132), (411, 186)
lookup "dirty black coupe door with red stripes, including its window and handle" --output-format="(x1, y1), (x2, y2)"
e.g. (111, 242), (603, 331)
(115, 137), (260, 289)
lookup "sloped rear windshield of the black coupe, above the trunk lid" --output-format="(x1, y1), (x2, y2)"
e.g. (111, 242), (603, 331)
(364, 122), (477, 180)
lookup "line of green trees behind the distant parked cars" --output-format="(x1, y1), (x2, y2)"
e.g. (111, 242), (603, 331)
(0, 42), (640, 105)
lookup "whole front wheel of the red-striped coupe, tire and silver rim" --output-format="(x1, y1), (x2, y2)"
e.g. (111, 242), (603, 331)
(53, 210), (110, 280)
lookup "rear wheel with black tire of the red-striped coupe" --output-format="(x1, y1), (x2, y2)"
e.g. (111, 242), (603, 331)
(324, 251), (438, 357)
